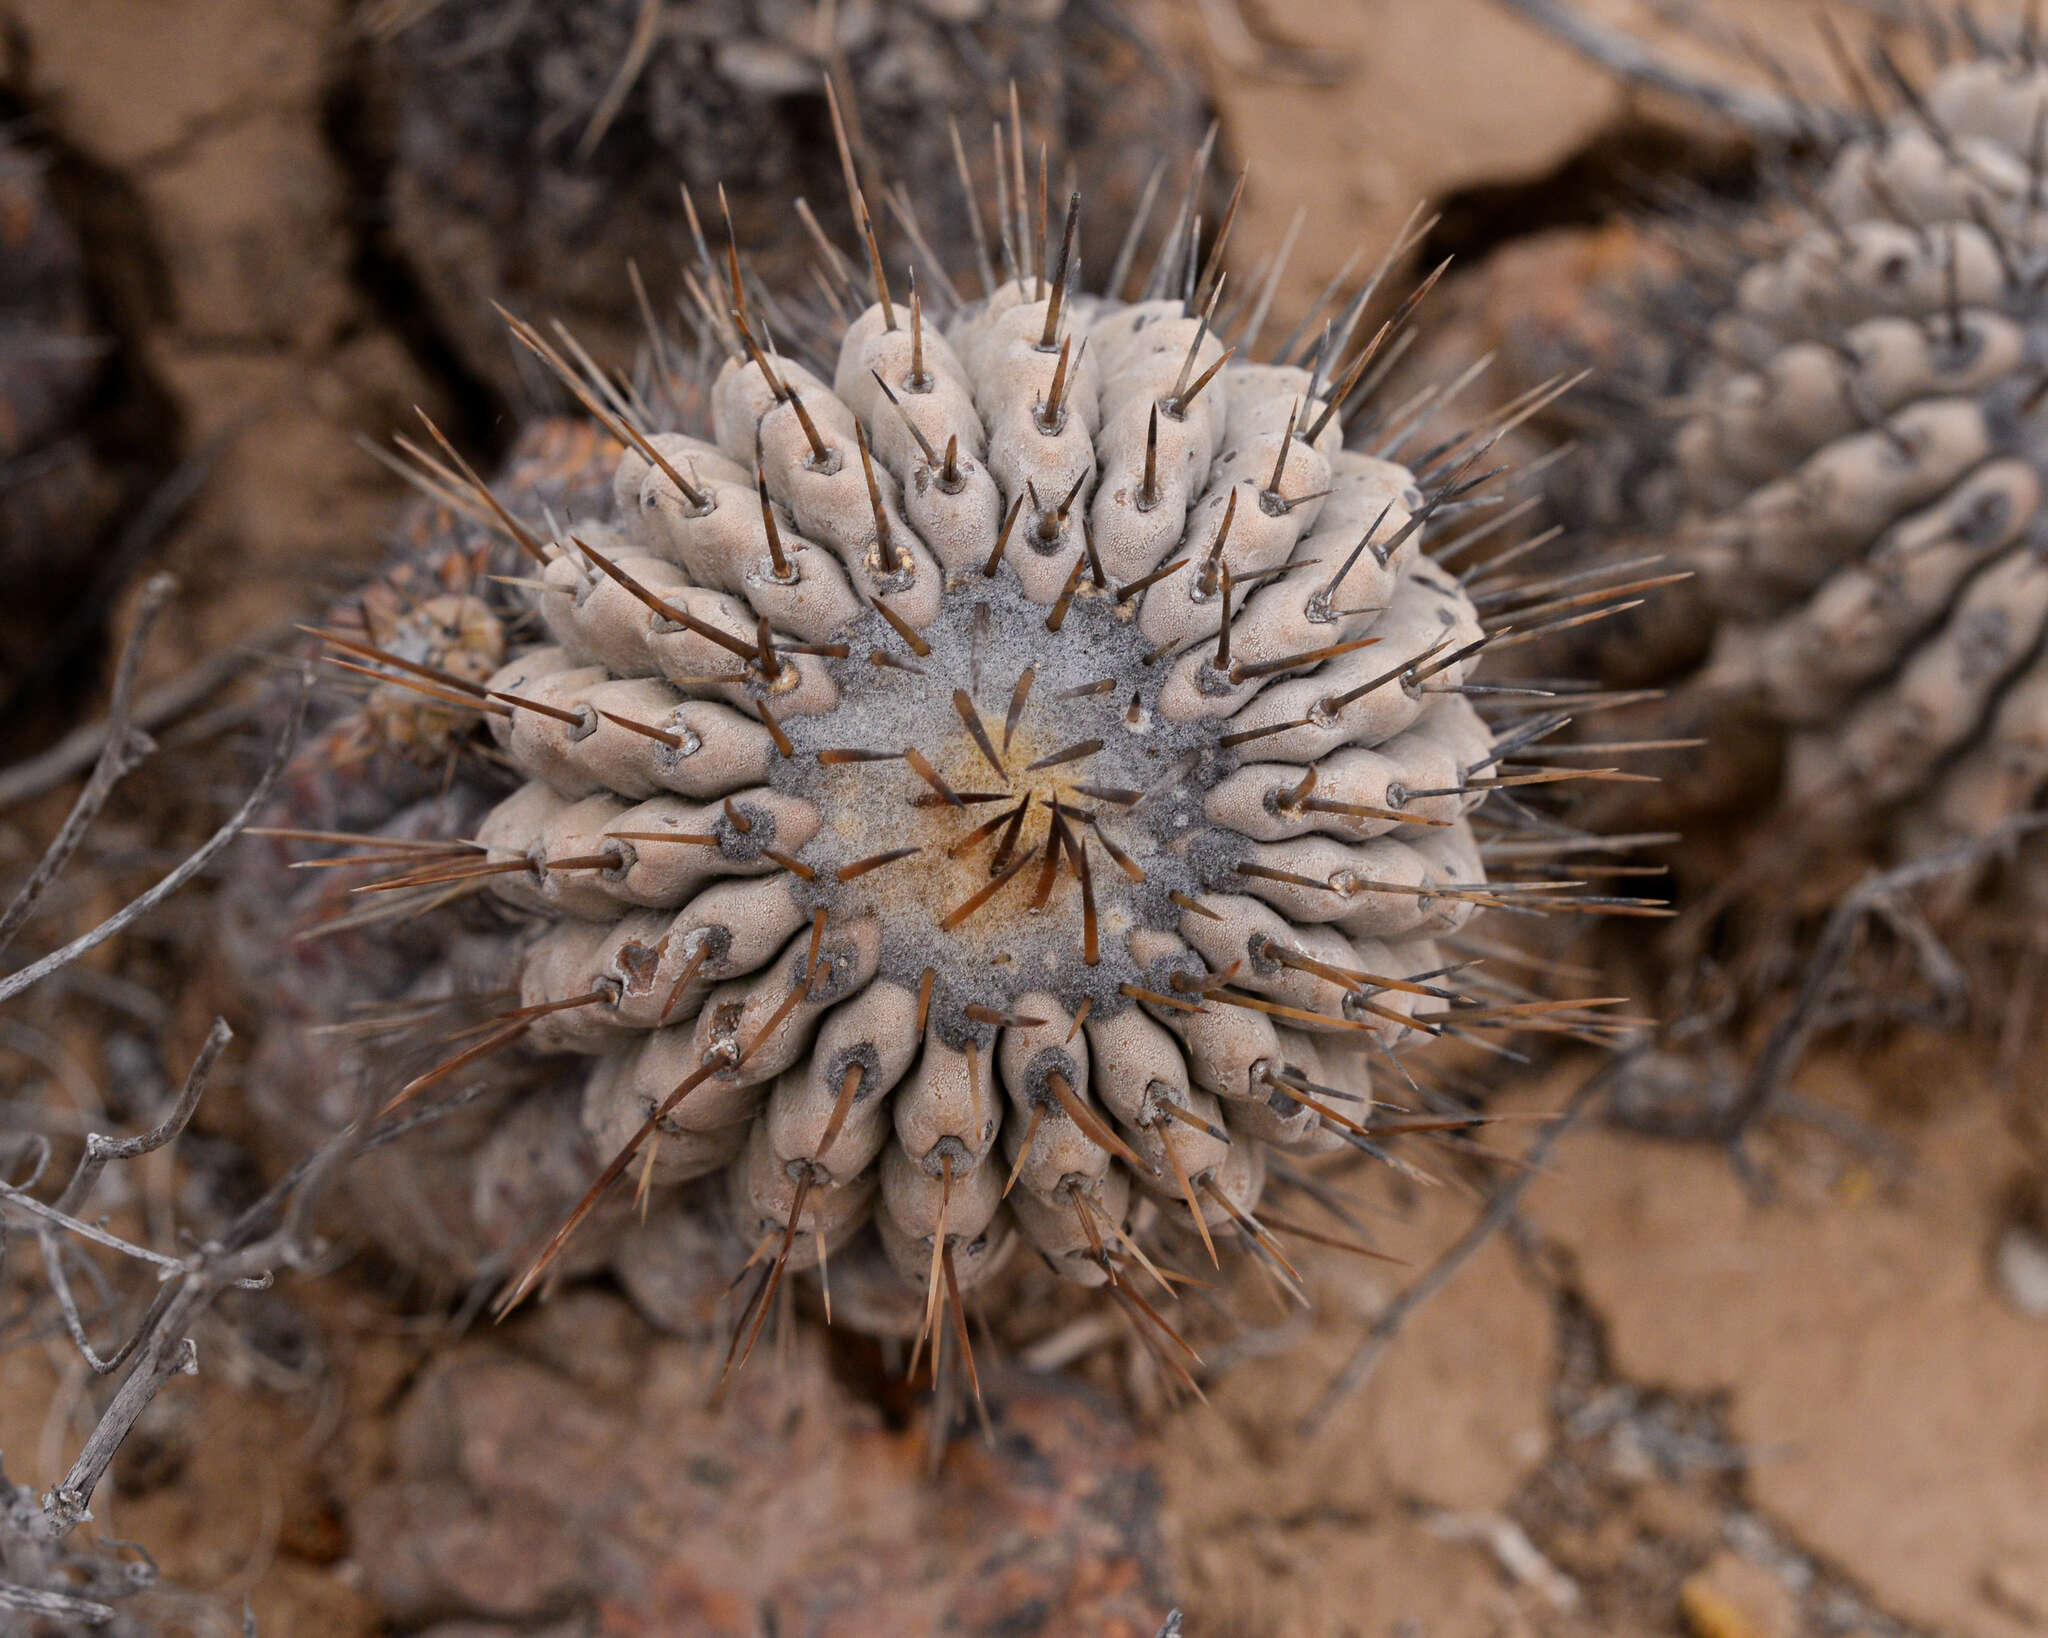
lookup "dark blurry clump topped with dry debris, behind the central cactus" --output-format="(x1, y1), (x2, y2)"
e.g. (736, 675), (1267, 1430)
(365, 0), (1221, 401)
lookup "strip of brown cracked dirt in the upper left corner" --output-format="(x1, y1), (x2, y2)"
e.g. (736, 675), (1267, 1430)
(6, 0), (444, 696)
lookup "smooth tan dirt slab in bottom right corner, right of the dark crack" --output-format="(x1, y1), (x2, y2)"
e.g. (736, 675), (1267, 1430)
(1530, 1044), (2048, 1638)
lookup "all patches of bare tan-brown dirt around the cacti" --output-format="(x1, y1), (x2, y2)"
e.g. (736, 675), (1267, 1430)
(0, 0), (2048, 1638)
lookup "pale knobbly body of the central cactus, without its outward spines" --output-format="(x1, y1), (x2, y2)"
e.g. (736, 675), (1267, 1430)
(460, 283), (1493, 1288)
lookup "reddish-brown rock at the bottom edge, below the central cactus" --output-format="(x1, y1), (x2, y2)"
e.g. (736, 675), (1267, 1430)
(352, 1294), (1169, 1638)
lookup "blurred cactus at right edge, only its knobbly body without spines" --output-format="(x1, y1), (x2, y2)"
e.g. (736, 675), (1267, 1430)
(1671, 53), (2048, 896)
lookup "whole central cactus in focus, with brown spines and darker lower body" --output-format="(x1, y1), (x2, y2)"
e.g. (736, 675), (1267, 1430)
(232, 112), (1638, 1392)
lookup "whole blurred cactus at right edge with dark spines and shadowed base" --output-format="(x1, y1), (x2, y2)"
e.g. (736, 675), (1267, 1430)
(1441, 0), (2048, 1064)
